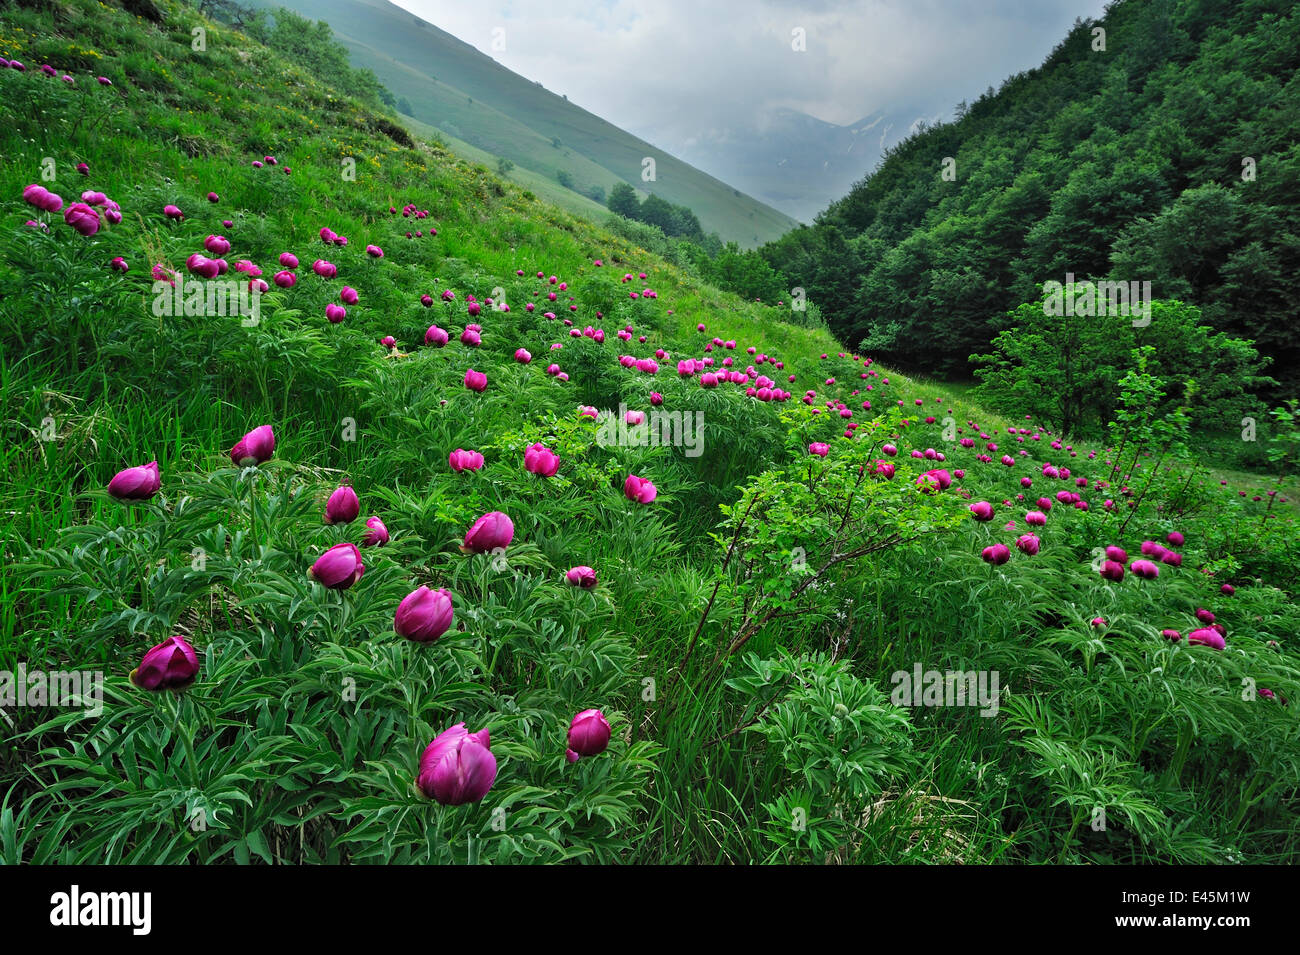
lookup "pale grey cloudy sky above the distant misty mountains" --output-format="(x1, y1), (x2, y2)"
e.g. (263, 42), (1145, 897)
(382, 0), (1105, 147)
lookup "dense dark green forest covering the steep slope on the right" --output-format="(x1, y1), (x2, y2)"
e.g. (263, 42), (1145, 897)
(762, 0), (1300, 398)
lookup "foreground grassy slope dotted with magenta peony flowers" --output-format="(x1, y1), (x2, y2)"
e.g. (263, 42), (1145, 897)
(0, 0), (1300, 863)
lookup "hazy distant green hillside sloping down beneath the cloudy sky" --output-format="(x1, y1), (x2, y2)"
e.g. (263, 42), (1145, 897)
(243, 0), (796, 248)
